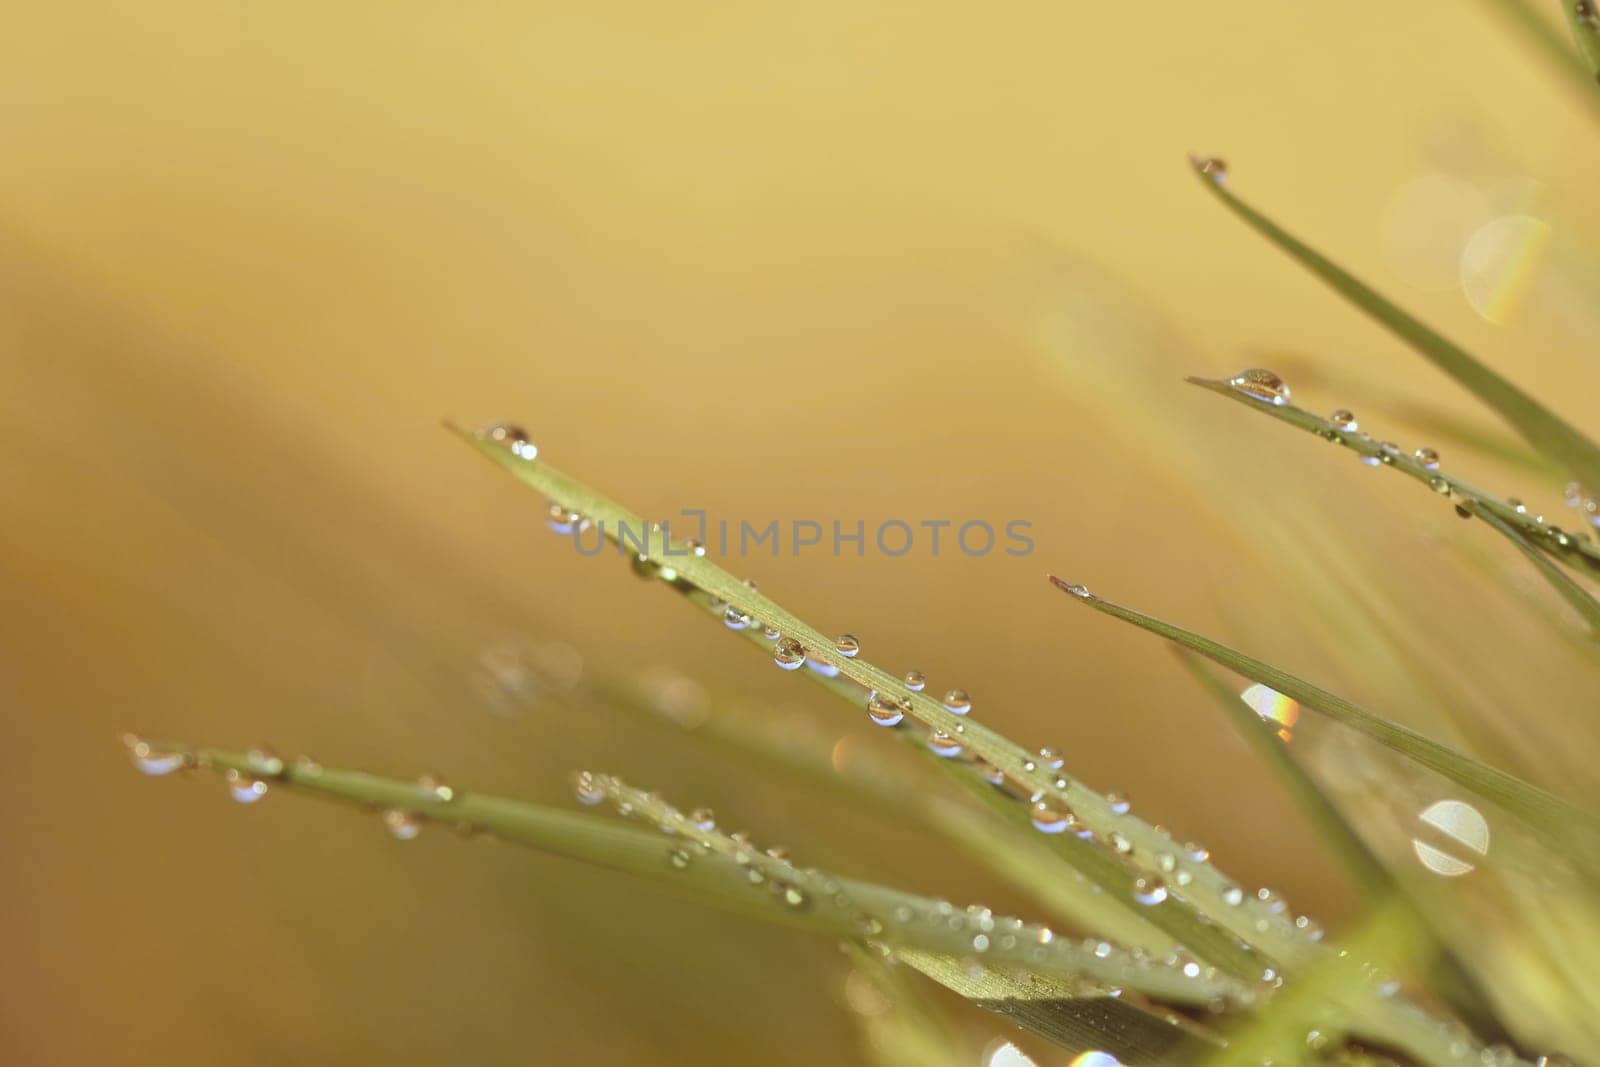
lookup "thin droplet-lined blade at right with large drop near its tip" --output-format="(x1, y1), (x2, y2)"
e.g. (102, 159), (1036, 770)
(1187, 378), (1600, 576)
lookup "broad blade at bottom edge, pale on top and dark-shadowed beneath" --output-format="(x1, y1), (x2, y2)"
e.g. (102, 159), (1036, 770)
(894, 950), (1222, 1064)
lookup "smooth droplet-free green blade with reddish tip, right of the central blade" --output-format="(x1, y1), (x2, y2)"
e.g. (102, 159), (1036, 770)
(1050, 574), (1600, 849)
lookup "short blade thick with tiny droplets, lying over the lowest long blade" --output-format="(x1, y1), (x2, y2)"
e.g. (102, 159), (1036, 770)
(573, 771), (1251, 1009)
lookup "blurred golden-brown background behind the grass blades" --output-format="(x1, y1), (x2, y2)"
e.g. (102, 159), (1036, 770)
(0, 0), (1600, 1067)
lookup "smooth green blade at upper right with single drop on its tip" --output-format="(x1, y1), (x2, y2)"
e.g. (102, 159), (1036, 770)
(1195, 167), (1600, 486)
